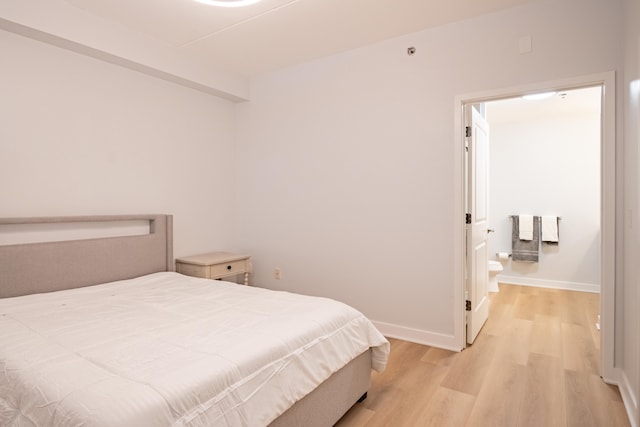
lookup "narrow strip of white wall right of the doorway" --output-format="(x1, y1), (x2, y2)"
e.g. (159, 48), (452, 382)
(616, 0), (640, 426)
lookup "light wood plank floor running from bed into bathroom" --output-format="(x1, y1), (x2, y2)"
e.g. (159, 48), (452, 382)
(337, 284), (630, 427)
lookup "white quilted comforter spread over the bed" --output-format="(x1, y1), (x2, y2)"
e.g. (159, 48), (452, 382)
(0, 273), (389, 427)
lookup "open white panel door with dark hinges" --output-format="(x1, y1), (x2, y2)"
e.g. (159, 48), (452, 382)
(465, 105), (489, 344)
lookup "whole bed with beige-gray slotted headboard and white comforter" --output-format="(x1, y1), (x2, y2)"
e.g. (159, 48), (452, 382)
(0, 215), (389, 427)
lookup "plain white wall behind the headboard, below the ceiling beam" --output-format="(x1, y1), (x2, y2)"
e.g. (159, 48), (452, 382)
(0, 31), (235, 256)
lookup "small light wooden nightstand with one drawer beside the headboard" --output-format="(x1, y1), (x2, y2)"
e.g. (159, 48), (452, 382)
(176, 252), (251, 285)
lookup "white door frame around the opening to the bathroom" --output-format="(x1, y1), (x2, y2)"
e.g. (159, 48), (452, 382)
(453, 71), (619, 383)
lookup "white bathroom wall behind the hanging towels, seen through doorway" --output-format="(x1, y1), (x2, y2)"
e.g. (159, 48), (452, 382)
(487, 103), (600, 292)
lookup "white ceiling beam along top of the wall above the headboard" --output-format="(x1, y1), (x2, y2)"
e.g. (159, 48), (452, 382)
(0, 0), (249, 102)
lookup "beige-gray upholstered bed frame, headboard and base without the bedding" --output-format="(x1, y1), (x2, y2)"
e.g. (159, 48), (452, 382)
(0, 215), (371, 427)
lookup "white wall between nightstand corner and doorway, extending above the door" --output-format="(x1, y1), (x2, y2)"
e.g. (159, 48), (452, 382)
(238, 0), (621, 345)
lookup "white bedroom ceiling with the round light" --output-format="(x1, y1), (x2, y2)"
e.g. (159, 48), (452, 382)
(65, 0), (535, 77)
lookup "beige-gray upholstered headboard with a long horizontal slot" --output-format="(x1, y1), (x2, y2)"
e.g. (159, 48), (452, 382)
(0, 215), (173, 298)
